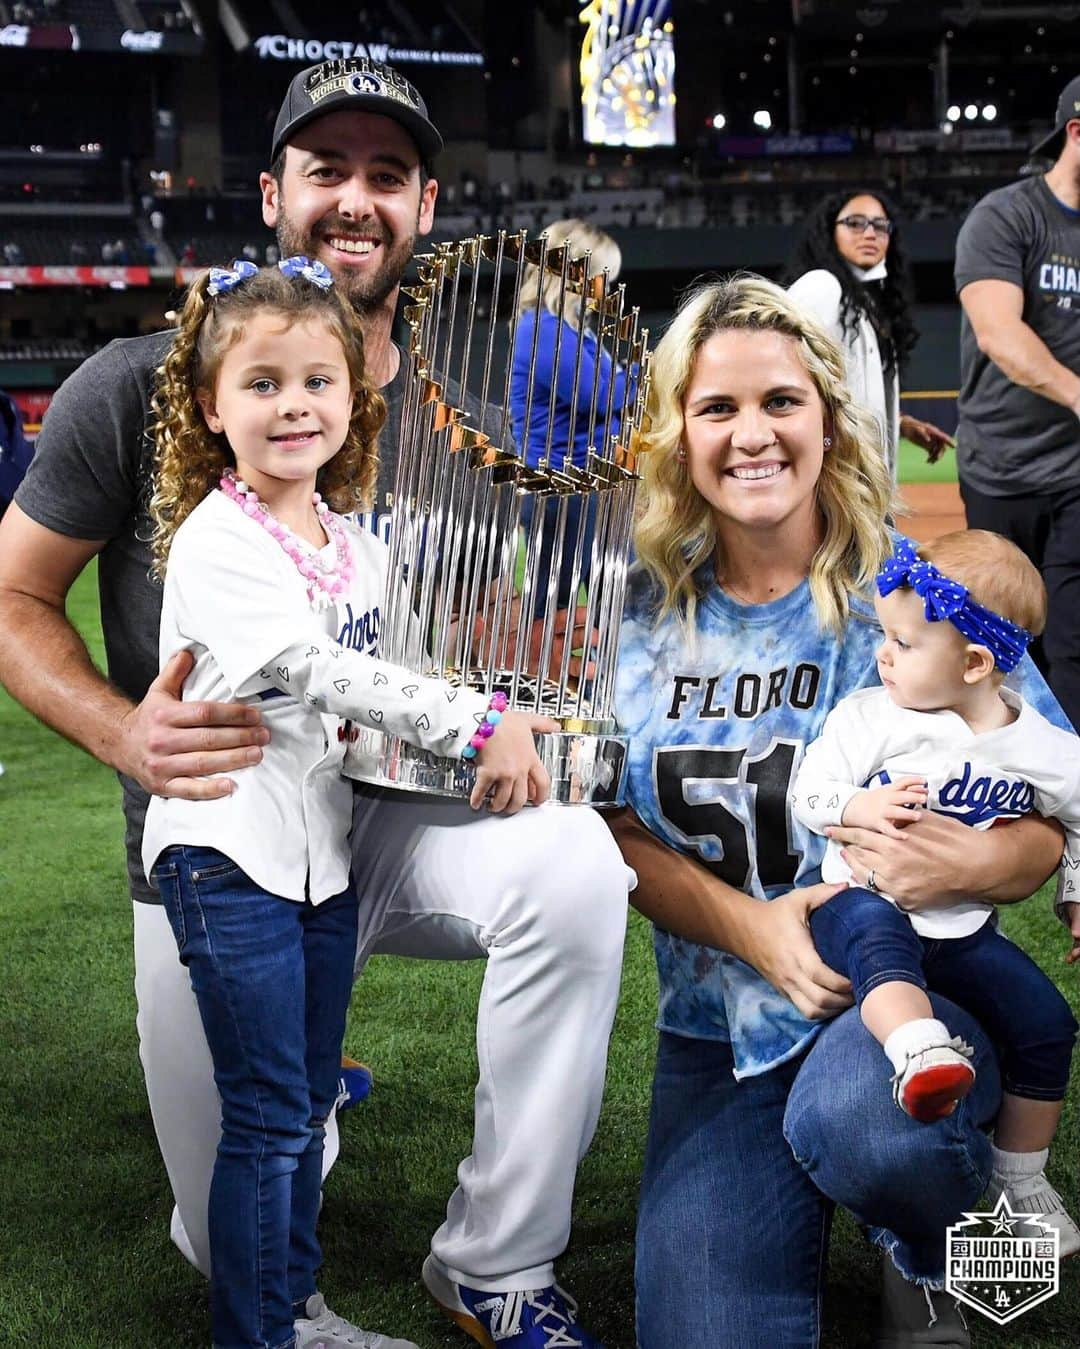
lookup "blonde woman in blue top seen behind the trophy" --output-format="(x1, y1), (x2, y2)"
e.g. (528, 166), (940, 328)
(510, 220), (626, 611)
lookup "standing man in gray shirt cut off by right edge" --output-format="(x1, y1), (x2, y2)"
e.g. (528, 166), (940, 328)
(956, 77), (1080, 727)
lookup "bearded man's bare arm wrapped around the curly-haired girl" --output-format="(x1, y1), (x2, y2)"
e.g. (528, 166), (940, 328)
(0, 505), (270, 800)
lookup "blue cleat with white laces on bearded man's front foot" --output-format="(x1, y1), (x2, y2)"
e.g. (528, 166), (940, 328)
(422, 1256), (604, 1349)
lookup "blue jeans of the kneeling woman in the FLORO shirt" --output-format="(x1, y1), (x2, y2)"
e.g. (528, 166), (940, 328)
(636, 998), (1000, 1349)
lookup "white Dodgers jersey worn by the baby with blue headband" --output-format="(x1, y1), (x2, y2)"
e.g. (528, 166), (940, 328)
(791, 688), (1080, 938)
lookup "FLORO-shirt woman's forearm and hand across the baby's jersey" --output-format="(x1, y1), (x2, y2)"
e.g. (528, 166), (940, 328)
(828, 811), (1065, 913)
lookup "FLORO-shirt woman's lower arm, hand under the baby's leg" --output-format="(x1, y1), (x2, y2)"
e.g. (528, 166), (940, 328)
(604, 809), (851, 1018)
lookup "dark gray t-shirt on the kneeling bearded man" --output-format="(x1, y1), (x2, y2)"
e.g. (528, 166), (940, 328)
(15, 332), (409, 904)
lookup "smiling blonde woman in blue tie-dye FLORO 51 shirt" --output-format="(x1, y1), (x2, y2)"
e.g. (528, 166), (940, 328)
(613, 277), (1061, 1349)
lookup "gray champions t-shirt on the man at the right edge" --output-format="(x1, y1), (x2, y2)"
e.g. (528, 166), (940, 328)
(956, 177), (1080, 496)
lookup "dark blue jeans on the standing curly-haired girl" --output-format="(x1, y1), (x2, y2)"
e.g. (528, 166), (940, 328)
(154, 847), (357, 1349)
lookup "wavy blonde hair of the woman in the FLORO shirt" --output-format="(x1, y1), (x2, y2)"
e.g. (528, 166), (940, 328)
(635, 274), (893, 633)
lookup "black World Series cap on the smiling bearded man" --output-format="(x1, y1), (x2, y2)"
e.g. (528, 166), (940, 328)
(270, 57), (442, 165)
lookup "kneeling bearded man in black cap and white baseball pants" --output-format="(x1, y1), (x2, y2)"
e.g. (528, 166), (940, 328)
(0, 58), (628, 1349)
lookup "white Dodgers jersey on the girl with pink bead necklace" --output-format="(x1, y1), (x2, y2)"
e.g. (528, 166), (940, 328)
(143, 491), (488, 904)
